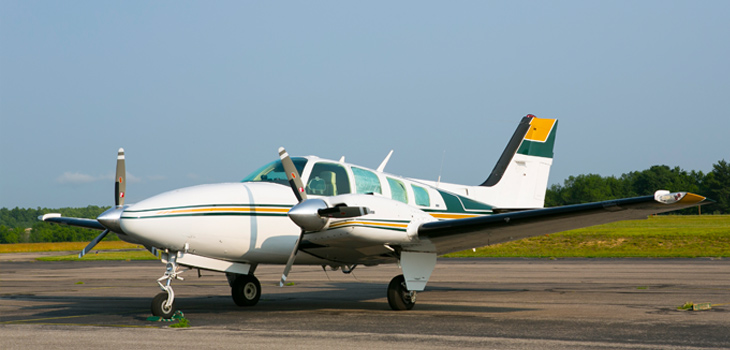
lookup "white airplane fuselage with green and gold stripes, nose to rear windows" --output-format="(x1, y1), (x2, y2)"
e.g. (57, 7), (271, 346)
(120, 157), (491, 265)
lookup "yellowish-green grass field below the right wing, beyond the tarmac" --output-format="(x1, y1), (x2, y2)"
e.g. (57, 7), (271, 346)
(446, 215), (730, 258)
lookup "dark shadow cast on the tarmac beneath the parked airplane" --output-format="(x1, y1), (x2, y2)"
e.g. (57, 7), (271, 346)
(0, 282), (533, 323)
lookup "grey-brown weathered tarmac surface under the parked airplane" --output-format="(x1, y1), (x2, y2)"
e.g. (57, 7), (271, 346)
(0, 254), (730, 349)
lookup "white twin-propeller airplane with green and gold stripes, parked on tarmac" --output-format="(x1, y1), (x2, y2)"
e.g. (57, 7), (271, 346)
(39, 115), (710, 318)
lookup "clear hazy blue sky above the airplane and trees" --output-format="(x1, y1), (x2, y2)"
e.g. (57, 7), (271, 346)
(0, 0), (730, 208)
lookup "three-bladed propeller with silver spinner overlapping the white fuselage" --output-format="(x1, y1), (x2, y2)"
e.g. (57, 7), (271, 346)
(279, 147), (373, 287)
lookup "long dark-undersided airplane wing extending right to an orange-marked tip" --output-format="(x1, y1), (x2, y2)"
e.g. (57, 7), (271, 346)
(418, 191), (711, 255)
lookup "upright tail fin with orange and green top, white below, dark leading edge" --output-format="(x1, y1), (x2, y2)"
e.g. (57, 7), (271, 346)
(477, 114), (558, 209)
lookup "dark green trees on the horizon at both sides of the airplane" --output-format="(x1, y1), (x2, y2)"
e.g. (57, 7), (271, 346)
(0, 160), (730, 243)
